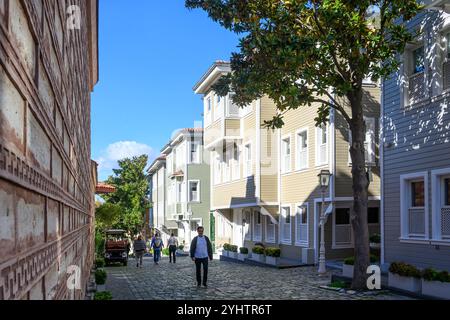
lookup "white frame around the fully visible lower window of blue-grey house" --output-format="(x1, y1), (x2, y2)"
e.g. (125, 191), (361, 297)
(400, 171), (429, 241)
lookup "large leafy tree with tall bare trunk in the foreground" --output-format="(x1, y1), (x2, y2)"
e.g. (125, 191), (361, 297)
(186, 0), (421, 289)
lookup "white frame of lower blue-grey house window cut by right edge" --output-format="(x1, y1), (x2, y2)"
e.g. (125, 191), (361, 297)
(431, 168), (450, 242)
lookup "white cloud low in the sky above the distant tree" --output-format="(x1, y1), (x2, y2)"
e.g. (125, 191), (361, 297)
(96, 141), (153, 180)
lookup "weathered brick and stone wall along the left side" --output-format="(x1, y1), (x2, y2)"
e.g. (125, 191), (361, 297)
(0, 0), (98, 300)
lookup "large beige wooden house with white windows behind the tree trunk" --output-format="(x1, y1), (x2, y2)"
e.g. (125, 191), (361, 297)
(194, 61), (380, 264)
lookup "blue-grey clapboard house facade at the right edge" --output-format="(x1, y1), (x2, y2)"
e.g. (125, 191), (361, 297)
(382, 1), (450, 270)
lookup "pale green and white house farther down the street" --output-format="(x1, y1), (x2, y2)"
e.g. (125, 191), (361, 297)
(149, 128), (210, 245)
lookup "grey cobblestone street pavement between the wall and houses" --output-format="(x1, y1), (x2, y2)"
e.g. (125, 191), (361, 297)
(106, 257), (412, 300)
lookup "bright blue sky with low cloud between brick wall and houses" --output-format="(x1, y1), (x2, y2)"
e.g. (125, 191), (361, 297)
(92, 0), (238, 180)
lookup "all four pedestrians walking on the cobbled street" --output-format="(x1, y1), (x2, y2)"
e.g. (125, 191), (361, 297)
(133, 227), (213, 287)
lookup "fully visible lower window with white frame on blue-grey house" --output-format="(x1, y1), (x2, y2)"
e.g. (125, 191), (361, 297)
(400, 172), (429, 239)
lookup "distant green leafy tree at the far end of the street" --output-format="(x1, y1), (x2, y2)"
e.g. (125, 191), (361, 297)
(102, 155), (150, 233)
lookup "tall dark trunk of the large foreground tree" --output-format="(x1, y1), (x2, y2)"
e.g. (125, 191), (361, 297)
(349, 89), (370, 290)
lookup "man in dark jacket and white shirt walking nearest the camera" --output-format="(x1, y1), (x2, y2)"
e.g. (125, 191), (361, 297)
(190, 227), (213, 288)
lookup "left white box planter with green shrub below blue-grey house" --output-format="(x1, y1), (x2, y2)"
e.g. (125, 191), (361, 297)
(388, 262), (422, 293)
